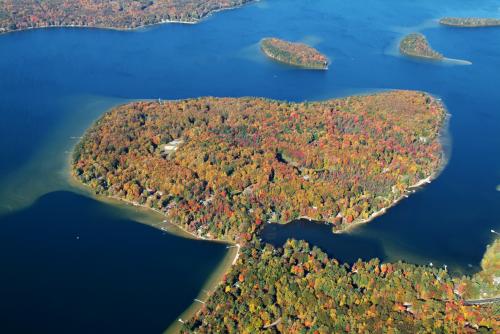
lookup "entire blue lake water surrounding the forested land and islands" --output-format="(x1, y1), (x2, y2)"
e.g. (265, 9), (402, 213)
(0, 0), (500, 333)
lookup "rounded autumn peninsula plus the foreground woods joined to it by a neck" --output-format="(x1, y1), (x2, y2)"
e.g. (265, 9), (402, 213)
(72, 91), (498, 333)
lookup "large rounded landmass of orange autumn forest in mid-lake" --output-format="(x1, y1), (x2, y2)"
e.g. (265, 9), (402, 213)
(73, 91), (445, 243)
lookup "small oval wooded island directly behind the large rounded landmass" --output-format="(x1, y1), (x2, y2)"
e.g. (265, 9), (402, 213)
(260, 38), (328, 70)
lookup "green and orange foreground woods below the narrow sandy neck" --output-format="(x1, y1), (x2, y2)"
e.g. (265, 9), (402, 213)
(182, 240), (500, 334)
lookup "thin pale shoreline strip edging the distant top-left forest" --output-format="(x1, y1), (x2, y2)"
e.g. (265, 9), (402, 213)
(0, 0), (260, 36)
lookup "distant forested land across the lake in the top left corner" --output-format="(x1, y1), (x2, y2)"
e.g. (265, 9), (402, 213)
(0, 0), (252, 33)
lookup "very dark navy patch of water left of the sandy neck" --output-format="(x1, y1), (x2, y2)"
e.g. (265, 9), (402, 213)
(0, 191), (226, 333)
